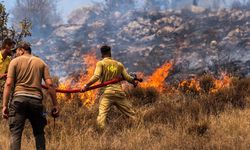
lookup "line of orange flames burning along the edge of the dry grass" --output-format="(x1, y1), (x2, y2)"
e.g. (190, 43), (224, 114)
(57, 53), (231, 107)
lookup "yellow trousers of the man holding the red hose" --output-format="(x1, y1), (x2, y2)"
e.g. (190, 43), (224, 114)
(97, 93), (136, 128)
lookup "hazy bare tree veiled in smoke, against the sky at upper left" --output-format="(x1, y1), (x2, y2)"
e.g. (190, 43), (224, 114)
(12, 0), (61, 36)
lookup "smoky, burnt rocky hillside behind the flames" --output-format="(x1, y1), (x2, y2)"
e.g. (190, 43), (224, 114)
(32, 6), (250, 80)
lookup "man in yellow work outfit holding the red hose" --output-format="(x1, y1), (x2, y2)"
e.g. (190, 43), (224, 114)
(83, 46), (136, 128)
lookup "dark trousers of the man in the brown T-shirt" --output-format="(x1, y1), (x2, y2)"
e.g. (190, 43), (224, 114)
(9, 96), (47, 150)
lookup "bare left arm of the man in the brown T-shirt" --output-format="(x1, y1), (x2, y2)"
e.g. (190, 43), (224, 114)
(2, 78), (14, 119)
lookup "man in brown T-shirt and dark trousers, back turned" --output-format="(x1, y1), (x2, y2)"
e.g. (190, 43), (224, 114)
(2, 42), (59, 150)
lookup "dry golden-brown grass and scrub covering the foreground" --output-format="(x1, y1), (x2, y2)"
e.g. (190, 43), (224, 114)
(0, 78), (250, 150)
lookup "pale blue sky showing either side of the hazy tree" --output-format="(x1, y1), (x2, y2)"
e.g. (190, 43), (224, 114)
(2, 0), (104, 19)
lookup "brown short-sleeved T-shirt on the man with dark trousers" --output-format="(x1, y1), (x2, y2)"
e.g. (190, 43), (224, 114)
(7, 55), (51, 97)
